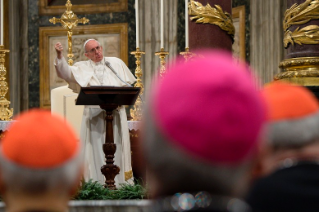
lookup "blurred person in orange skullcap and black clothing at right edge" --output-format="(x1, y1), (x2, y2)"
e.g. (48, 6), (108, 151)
(247, 82), (319, 212)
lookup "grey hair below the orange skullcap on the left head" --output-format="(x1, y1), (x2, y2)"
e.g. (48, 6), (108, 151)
(0, 150), (83, 195)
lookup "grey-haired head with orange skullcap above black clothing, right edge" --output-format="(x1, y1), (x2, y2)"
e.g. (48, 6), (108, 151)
(262, 82), (319, 174)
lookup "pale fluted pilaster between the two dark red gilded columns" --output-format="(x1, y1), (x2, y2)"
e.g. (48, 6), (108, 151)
(250, 0), (286, 84)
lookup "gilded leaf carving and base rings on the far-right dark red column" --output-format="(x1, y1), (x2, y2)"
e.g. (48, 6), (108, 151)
(274, 0), (319, 86)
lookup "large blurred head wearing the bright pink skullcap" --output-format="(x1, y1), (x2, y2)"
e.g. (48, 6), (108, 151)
(142, 51), (265, 205)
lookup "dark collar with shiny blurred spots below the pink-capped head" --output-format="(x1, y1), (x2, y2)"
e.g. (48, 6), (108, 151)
(154, 191), (251, 212)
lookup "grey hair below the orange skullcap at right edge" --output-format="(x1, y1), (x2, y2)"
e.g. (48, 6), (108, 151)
(267, 112), (319, 149)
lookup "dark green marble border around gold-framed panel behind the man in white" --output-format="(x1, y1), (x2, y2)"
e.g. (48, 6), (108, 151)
(28, 0), (135, 108)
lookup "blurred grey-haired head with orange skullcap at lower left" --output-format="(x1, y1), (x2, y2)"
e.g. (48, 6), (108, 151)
(0, 109), (83, 211)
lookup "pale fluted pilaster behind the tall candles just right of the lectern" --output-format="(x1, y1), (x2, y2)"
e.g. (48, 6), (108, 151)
(139, 0), (179, 96)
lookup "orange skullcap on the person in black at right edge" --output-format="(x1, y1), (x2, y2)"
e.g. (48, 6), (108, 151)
(262, 82), (319, 121)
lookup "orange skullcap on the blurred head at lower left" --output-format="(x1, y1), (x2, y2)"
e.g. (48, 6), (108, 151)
(0, 109), (80, 169)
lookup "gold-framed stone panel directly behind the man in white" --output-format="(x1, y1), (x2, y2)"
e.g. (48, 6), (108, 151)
(39, 23), (128, 108)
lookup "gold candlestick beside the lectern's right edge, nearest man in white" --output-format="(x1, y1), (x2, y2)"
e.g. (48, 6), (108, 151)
(130, 48), (145, 121)
